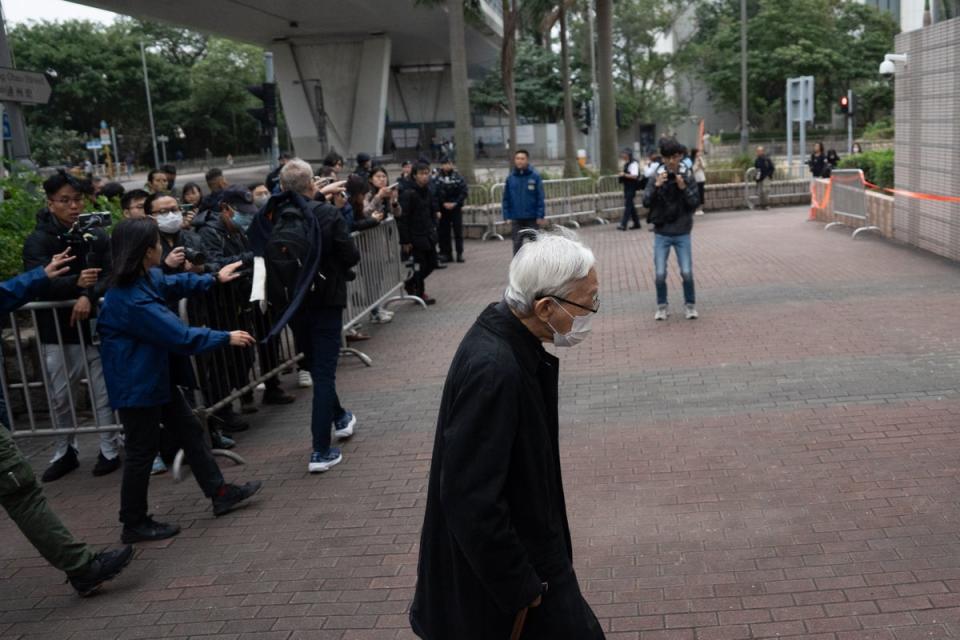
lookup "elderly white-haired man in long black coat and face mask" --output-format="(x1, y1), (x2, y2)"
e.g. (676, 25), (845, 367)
(410, 231), (604, 640)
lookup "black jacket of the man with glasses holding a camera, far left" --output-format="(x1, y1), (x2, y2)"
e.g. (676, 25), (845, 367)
(23, 208), (111, 344)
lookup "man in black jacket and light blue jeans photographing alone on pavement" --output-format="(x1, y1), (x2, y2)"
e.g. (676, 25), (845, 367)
(643, 138), (700, 320)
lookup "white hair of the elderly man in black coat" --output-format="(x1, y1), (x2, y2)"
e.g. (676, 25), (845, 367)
(503, 227), (597, 315)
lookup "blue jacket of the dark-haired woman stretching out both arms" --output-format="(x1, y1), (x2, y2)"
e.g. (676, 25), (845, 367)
(97, 269), (230, 409)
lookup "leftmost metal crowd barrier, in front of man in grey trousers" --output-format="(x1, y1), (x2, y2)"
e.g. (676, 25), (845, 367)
(0, 300), (123, 437)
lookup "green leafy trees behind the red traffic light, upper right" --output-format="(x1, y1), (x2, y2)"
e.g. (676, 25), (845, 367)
(690, 0), (897, 129)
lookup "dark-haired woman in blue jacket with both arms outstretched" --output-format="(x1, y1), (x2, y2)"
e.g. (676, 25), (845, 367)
(97, 218), (260, 543)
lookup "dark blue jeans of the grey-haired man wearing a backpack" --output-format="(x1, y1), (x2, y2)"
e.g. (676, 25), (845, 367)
(293, 307), (343, 453)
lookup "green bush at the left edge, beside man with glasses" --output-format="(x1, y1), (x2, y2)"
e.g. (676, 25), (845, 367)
(0, 174), (44, 280)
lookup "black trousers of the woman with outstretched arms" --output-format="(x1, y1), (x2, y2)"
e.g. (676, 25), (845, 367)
(119, 387), (223, 526)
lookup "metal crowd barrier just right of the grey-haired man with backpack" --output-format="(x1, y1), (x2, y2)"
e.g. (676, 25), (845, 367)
(340, 217), (427, 367)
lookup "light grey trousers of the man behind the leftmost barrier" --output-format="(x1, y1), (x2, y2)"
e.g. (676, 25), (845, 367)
(40, 344), (120, 462)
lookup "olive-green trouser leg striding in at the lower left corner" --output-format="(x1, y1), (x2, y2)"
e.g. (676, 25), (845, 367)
(0, 426), (94, 576)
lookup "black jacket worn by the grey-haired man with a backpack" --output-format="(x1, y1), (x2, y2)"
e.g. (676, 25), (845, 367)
(300, 203), (360, 310)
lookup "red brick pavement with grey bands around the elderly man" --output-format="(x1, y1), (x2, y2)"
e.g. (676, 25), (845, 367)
(0, 209), (960, 640)
